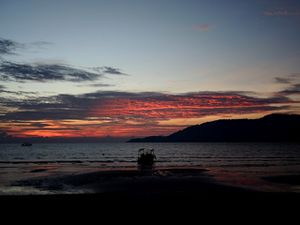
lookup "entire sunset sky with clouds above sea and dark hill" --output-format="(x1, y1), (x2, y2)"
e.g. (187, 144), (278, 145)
(0, 0), (300, 137)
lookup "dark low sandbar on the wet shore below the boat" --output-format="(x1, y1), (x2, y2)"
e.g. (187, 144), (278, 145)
(12, 168), (251, 197)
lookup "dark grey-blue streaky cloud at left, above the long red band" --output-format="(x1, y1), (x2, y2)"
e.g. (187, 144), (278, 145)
(0, 61), (102, 82)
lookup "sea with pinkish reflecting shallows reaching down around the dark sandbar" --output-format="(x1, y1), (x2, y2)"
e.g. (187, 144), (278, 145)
(0, 143), (300, 195)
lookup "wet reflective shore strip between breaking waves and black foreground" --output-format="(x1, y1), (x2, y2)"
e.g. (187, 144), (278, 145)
(0, 164), (300, 195)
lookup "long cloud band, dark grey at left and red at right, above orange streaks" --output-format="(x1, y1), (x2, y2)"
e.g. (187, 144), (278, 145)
(0, 91), (292, 121)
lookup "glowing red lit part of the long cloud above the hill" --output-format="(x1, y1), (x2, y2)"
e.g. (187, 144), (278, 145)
(89, 94), (288, 120)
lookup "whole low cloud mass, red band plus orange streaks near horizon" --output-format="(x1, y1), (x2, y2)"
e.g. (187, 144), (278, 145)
(0, 91), (293, 136)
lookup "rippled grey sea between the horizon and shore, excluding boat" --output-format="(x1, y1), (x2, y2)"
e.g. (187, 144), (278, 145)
(0, 143), (300, 167)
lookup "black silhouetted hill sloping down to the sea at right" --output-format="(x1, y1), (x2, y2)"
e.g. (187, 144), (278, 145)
(128, 114), (300, 142)
